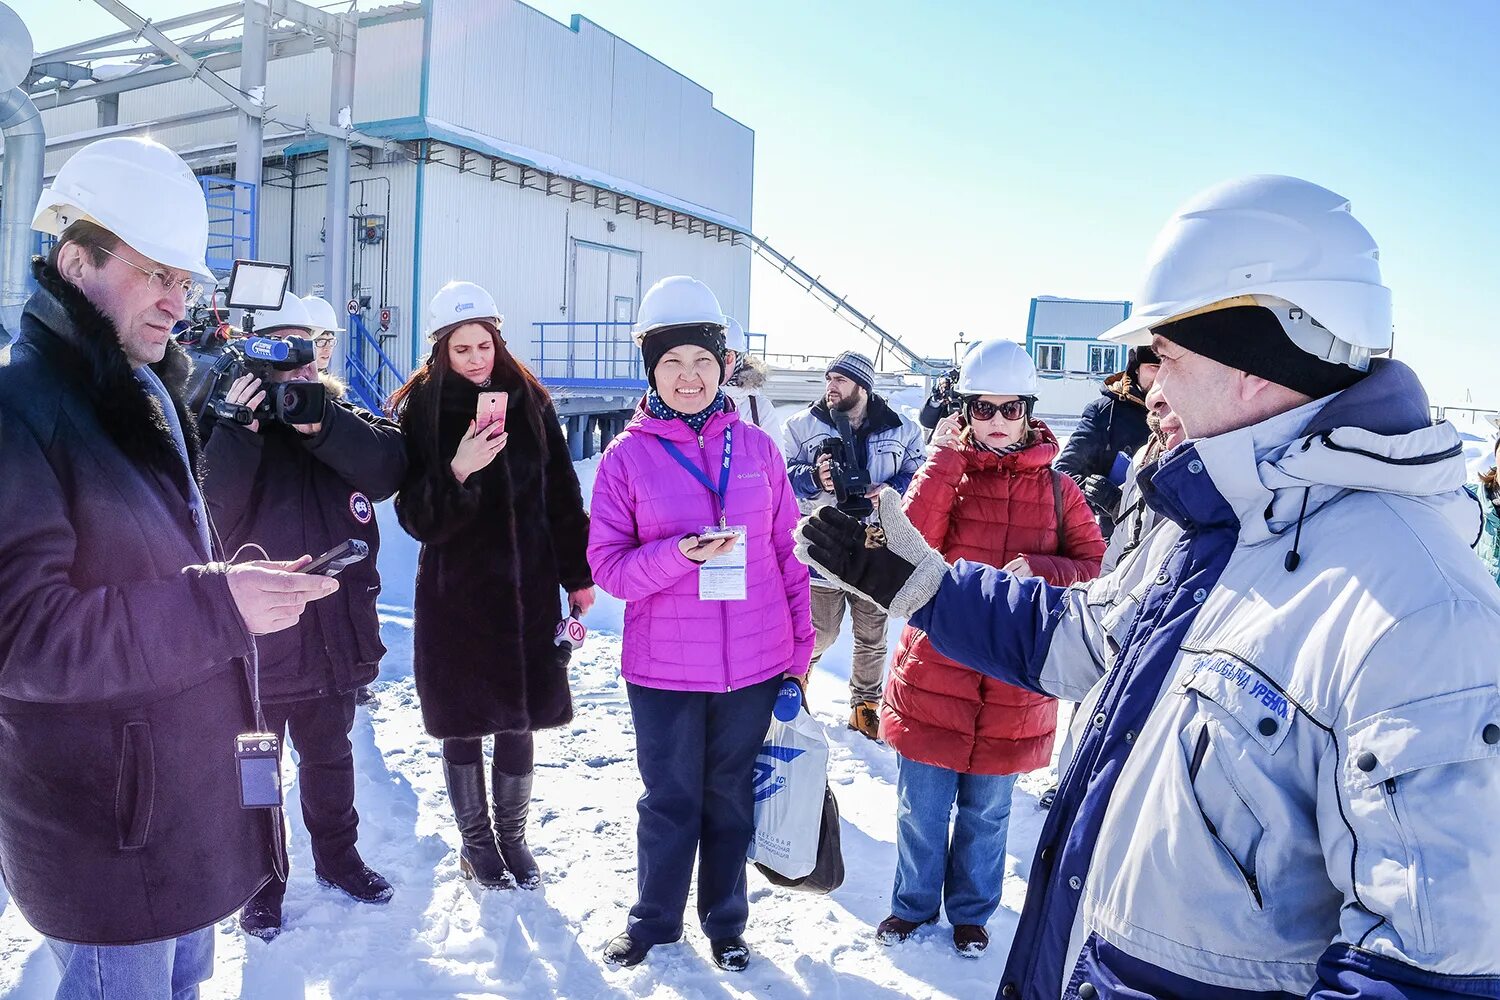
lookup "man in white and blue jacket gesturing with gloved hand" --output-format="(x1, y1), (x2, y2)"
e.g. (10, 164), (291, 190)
(798, 177), (1500, 1000)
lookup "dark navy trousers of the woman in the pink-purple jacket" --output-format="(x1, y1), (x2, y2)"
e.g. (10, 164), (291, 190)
(626, 676), (782, 945)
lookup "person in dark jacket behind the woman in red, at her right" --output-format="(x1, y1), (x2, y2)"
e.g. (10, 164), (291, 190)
(1055, 345), (1160, 541)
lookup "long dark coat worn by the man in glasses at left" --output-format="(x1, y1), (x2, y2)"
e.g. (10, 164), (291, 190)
(0, 262), (273, 945)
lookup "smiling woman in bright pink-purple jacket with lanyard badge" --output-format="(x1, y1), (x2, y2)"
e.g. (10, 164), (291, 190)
(588, 276), (813, 972)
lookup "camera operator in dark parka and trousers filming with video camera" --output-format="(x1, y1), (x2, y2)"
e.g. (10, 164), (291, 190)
(204, 294), (407, 940)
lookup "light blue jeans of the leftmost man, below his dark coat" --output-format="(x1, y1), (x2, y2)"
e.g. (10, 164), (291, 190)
(47, 927), (213, 1000)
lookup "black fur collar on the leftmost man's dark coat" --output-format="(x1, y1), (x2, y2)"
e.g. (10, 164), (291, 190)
(26, 258), (203, 483)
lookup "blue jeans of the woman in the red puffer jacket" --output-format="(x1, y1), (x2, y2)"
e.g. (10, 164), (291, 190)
(891, 754), (1016, 927)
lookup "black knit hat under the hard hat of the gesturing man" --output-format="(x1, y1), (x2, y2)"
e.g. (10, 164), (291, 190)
(1151, 306), (1365, 399)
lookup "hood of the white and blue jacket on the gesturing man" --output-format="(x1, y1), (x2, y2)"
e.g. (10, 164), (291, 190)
(1196, 360), (1479, 541)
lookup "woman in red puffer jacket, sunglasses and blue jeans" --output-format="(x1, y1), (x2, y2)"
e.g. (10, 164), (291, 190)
(876, 339), (1104, 957)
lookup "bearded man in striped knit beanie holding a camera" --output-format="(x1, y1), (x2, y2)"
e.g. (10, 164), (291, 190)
(782, 351), (924, 739)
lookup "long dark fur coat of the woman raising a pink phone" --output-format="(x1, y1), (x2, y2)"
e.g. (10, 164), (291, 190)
(396, 369), (593, 738)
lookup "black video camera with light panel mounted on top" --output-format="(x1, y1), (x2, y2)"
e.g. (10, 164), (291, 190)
(182, 261), (327, 424)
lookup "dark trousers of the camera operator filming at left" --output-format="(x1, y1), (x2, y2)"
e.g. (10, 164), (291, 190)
(260, 691), (365, 898)
